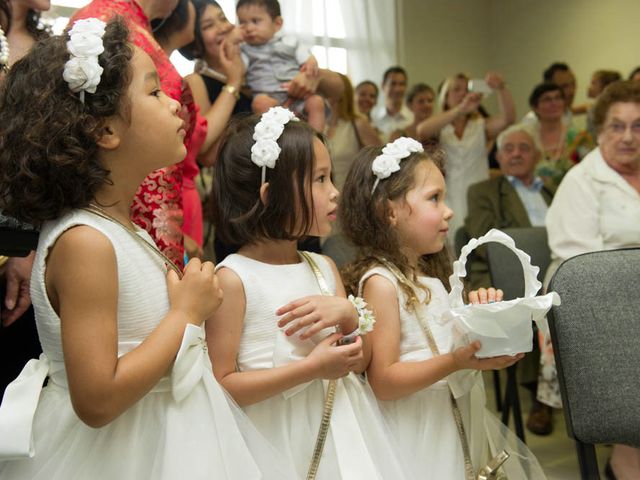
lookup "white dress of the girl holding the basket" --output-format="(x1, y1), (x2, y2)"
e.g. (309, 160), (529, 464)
(360, 267), (545, 480)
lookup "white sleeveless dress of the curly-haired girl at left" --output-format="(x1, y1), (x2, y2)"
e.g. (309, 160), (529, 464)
(0, 211), (295, 480)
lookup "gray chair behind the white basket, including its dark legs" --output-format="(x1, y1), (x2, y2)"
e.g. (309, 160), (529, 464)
(486, 227), (551, 442)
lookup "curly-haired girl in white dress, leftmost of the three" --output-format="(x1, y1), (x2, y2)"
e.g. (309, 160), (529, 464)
(0, 19), (296, 480)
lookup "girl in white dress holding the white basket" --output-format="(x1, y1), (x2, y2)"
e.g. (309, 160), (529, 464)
(339, 137), (544, 480)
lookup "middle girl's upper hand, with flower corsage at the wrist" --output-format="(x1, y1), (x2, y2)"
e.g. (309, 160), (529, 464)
(276, 295), (358, 340)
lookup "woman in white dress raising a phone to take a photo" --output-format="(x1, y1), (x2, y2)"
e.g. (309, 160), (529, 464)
(417, 72), (515, 236)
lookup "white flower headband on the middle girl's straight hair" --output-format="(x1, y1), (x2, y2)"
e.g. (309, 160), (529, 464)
(251, 107), (298, 185)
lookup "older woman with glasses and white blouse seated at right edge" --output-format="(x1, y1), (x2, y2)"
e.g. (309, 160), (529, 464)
(538, 81), (640, 478)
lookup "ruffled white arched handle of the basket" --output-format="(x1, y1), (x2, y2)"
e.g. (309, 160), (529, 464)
(449, 228), (542, 308)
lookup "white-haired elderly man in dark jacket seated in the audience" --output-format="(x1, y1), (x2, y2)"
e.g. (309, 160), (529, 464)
(465, 124), (555, 435)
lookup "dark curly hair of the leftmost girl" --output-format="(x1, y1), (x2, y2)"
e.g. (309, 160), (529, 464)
(0, 18), (133, 224)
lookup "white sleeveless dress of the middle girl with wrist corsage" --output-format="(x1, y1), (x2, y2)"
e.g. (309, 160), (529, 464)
(217, 254), (408, 480)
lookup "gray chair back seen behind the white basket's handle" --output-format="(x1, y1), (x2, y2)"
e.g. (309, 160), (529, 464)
(486, 227), (551, 300)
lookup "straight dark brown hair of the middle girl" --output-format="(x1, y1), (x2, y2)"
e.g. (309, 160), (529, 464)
(211, 115), (323, 245)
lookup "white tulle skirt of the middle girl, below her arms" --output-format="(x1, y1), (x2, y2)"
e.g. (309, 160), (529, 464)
(244, 374), (411, 480)
